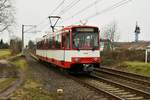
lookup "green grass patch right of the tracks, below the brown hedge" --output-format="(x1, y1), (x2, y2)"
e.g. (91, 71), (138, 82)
(120, 61), (150, 77)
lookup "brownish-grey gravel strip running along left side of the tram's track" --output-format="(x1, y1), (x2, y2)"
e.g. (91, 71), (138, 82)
(26, 56), (108, 100)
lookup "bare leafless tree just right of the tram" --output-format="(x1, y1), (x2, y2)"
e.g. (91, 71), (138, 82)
(102, 21), (120, 50)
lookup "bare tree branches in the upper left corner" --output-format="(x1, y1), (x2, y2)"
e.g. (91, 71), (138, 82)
(0, 0), (15, 33)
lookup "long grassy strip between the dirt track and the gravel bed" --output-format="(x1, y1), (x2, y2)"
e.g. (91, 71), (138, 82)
(10, 57), (53, 100)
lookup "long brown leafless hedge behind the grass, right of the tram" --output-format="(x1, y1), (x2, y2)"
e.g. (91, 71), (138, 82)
(101, 50), (150, 65)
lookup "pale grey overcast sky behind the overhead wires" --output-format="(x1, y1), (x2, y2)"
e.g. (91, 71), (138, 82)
(0, 0), (150, 44)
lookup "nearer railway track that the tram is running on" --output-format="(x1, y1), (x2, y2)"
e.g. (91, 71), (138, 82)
(30, 53), (150, 100)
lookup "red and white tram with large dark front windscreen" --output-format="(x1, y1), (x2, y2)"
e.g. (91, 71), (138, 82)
(36, 25), (101, 73)
